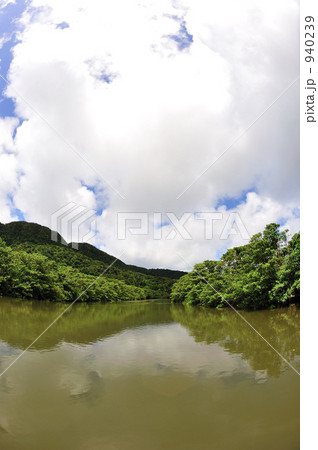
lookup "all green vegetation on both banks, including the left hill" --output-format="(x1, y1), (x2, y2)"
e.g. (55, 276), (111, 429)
(0, 222), (300, 310)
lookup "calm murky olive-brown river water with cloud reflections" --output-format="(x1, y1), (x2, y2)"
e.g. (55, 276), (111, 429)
(0, 299), (299, 450)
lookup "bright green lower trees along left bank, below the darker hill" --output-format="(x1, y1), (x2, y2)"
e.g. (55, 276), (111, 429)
(0, 238), (147, 302)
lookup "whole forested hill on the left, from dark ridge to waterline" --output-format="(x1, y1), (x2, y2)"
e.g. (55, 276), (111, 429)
(0, 221), (185, 301)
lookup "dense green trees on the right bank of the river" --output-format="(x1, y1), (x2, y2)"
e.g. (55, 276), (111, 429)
(171, 223), (300, 310)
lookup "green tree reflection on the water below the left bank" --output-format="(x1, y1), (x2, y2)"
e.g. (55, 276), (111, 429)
(0, 299), (173, 350)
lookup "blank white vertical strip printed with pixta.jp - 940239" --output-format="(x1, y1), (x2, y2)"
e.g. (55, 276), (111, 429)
(300, 0), (318, 449)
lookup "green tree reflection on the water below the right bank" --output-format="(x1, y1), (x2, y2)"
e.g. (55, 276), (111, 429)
(172, 306), (300, 376)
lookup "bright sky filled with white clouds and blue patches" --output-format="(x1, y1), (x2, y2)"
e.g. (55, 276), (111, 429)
(0, 0), (299, 270)
